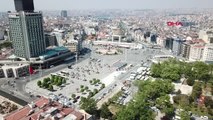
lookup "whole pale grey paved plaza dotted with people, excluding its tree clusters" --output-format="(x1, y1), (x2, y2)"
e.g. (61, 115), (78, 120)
(25, 46), (163, 105)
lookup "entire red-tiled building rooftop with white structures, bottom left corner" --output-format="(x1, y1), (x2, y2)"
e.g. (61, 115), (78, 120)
(4, 97), (84, 120)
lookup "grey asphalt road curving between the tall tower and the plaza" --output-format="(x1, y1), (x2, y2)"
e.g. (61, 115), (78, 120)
(0, 43), (91, 102)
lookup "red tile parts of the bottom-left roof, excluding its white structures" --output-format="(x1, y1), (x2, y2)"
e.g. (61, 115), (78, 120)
(4, 97), (83, 120)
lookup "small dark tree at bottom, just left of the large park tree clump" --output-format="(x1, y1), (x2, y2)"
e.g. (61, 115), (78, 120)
(100, 103), (113, 119)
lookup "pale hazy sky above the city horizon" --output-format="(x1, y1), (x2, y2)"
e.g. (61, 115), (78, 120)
(0, 0), (213, 11)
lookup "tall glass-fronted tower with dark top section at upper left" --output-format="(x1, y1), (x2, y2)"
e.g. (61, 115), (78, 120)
(8, 0), (46, 60)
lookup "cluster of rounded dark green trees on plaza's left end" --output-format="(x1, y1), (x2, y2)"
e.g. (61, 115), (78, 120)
(37, 75), (66, 91)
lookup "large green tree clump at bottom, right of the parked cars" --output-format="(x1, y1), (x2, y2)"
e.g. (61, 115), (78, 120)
(117, 80), (174, 120)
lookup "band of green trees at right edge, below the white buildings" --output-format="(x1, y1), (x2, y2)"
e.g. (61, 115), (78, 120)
(151, 59), (213, 85)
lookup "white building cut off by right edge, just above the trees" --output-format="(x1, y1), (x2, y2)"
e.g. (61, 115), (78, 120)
(202, 44), (213, 61)
